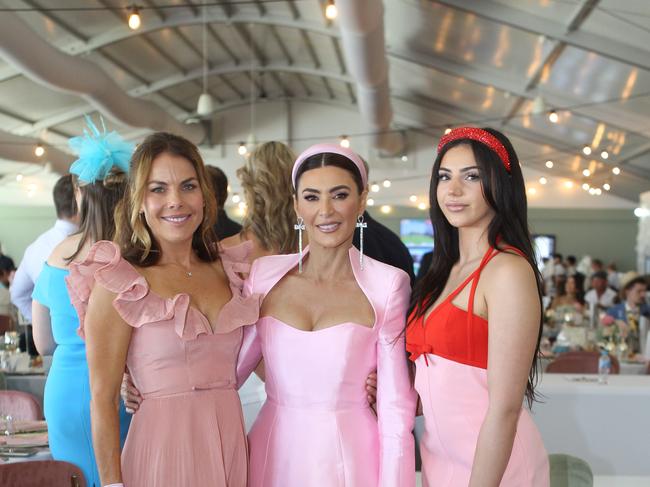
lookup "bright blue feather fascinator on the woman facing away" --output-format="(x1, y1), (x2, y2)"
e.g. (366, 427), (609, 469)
(68, 115), (135, 184)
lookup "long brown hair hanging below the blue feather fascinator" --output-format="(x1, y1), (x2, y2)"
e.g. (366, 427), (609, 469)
(66, 169), (127, 262)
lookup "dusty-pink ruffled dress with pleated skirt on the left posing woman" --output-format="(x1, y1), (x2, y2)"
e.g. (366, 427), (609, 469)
(68, 241), (259, 487)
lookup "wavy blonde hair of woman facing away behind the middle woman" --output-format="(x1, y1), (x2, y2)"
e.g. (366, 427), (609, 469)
(237, 142), (298, 254)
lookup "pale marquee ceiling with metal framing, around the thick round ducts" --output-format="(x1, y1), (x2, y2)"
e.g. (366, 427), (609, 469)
(0, 0), (650, 206)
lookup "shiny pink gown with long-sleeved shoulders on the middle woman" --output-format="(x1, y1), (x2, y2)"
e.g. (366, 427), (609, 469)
(238, 249), (415, 487)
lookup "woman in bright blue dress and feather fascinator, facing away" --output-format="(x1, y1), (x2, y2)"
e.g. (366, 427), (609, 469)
(32, 119), (133, 487)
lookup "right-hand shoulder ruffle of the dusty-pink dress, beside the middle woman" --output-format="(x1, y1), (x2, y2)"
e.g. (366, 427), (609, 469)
(214, 240), (262, 333)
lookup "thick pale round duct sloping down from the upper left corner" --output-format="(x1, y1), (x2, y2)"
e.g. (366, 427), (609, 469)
(0, 12), (205, 143)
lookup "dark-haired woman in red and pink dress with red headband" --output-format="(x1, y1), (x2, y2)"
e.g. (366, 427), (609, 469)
(406, 127), (549, 487)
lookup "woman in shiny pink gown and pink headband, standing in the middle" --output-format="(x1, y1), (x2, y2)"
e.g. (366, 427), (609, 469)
(238, 144), (415, 487)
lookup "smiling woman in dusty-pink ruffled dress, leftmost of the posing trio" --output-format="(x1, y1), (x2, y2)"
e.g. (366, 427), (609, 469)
(69, 133), (259, 487)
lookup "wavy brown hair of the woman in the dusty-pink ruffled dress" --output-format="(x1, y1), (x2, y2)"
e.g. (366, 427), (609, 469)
(115, 132), (219, 267)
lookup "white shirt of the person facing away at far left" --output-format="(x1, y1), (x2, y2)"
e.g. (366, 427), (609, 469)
(10, 220), (77, 321)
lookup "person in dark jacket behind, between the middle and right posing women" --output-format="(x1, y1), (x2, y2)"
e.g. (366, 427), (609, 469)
(352, 159), (415, 286)
